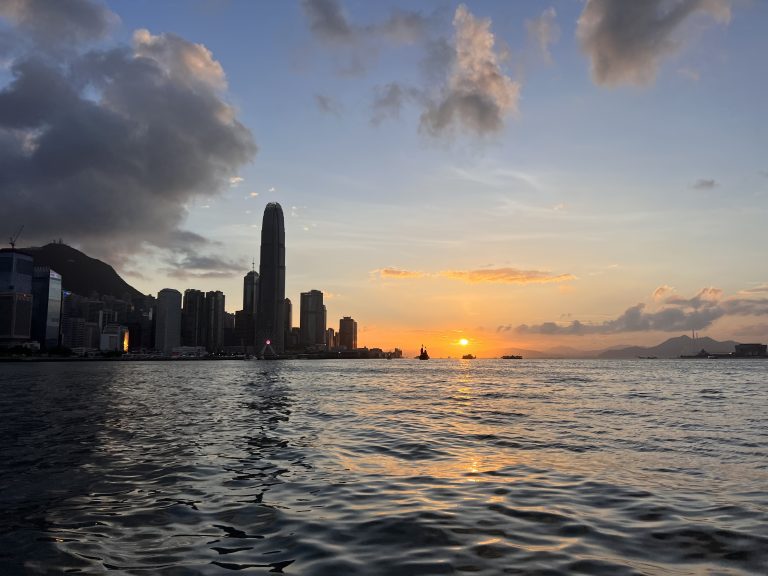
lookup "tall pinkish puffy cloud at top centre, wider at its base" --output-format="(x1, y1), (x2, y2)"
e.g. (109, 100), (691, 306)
(420, 4), (520, 136)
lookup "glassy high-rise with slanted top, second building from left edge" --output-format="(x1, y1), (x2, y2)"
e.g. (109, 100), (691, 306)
(32, 266), (62, 350)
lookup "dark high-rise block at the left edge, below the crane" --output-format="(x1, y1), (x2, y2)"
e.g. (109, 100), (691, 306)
(0, 250), (33, 346)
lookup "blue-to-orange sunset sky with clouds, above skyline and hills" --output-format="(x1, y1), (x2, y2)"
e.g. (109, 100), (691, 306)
(0, 0), (768, 356)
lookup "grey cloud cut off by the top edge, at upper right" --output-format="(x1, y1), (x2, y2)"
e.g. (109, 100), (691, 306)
(576, 0), (731, 86)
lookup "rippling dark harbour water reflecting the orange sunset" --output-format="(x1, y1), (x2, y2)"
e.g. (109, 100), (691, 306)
(0, 360), (768, 576)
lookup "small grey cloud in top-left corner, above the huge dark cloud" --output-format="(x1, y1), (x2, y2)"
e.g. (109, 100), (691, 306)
(0, 0), (119, 47)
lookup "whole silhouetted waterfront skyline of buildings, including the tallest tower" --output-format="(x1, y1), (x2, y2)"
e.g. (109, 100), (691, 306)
(0, 203), (402, 357)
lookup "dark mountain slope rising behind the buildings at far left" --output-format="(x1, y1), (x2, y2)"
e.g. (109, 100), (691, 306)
(19, 243), (143, 300)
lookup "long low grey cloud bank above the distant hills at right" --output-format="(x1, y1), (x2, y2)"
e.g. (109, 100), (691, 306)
(516, 288), (768, 336)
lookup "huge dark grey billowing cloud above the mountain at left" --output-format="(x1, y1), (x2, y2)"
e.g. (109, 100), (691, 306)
(0, 9), (257, 261)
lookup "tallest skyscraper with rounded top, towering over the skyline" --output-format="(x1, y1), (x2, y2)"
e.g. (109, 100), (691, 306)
(256, 202), (285, 354)
